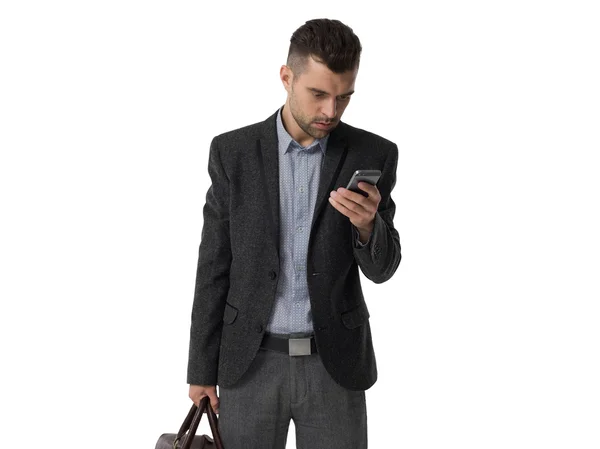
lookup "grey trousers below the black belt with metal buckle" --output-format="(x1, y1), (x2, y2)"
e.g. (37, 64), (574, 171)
(219, 348), (367, 449)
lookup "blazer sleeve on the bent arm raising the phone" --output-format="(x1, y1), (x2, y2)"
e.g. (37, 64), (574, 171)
(353, 144), (402, 284)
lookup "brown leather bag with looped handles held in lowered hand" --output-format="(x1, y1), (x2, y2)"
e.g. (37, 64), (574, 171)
(155, 396), (224, 449)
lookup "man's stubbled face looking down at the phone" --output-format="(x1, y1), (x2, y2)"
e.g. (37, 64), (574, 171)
(281, 54), (358, 145)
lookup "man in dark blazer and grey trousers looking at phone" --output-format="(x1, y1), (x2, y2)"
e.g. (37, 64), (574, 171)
(187, 19), (401, 449)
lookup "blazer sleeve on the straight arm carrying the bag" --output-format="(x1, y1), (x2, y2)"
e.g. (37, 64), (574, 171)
(187, 137), (232, 385)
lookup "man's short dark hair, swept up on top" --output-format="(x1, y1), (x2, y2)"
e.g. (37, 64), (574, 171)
(287, 19), (362, 76)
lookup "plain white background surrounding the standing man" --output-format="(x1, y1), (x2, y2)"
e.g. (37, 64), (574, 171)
(0, 0), (600, 449)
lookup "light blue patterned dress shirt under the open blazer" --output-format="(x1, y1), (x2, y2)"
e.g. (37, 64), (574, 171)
(266, 108), (371, 335)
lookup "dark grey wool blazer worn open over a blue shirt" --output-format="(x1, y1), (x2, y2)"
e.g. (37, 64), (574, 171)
(187, 107), (401, 390)
